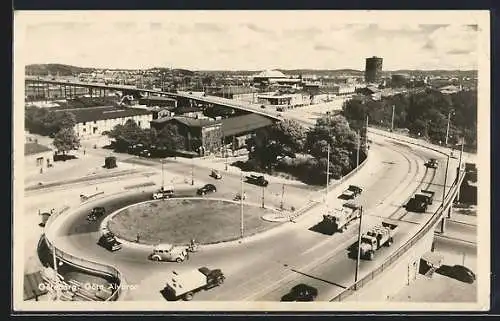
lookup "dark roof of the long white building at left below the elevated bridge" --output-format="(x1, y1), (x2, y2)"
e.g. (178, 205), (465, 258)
(52, 106), (151, 123)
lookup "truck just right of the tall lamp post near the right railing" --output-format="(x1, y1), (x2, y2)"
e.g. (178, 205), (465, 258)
(356, 222), (398, 260)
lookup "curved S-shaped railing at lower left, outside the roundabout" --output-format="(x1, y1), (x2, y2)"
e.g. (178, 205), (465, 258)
(42, 194), (124, 301)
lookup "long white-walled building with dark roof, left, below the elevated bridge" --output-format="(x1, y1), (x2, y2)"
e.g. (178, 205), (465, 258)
(52, 106), (153, 139)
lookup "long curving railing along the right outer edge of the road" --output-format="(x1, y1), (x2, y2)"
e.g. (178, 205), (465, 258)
(330, 170), (465, 302)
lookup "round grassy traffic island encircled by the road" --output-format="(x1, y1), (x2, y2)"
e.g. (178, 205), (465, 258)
(108, 198), (282, 245)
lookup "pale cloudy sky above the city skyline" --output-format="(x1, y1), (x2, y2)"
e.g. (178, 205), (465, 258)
(14, 11), (484, 70)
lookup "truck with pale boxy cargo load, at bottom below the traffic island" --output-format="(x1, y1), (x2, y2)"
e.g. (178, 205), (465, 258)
(163, 267), (226, 301)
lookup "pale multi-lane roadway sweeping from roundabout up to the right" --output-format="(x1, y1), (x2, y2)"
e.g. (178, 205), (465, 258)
(40, 132), (454, 301)
